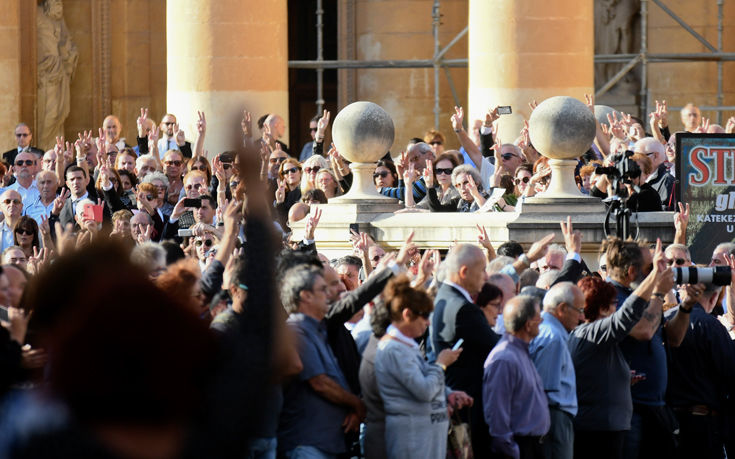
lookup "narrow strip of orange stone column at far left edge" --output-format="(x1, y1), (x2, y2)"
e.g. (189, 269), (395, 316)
(0, 0), (21, 151)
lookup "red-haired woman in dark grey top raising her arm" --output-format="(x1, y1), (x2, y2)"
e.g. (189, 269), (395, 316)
(568, 248), (673, 459)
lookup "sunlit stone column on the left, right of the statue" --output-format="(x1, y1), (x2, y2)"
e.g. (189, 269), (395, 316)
(166, 0), (288, 155)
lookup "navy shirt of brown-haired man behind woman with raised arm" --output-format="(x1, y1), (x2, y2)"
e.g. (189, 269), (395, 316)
(609, 279), (668, 406)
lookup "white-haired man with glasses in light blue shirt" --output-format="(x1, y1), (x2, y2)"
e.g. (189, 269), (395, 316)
(528, 282), (584, 459)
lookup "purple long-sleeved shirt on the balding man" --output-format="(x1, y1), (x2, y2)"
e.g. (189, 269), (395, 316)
(482, 334), (551, 459)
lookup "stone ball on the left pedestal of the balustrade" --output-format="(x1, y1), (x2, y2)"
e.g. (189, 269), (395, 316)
(332, 101), (395, 163)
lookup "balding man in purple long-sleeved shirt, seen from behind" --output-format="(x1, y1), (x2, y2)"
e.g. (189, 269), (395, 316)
(482, 296), (551, 459)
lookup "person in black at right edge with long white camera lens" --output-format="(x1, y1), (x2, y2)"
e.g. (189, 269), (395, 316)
(666, 266), (735, 458)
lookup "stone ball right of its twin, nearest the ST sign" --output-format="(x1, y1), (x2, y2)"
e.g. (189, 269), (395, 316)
(528, 96), (595, 159)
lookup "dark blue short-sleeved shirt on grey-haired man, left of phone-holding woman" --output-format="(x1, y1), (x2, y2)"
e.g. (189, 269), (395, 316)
(278, 313), (350, 454)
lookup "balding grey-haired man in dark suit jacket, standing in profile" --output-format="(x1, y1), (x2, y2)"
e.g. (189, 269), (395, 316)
(431, 244), (499, 457)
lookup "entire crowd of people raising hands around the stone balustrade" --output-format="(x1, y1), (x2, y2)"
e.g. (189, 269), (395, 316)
(0, 97), (735, 459)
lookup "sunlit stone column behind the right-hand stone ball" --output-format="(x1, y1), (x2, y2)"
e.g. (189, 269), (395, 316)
(466, 0), (594, 138)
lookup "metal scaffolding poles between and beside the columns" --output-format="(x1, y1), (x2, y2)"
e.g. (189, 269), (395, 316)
(288, 0), (735, 129)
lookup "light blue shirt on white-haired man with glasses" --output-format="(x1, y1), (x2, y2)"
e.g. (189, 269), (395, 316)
(528, 312), (577, 416)
